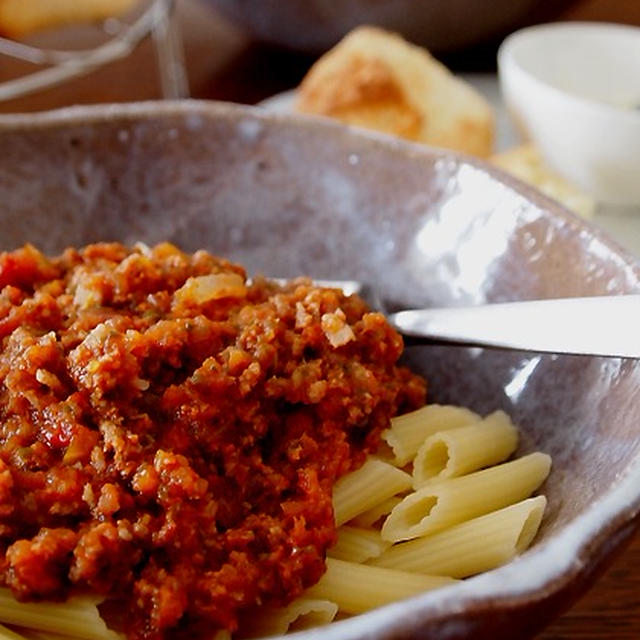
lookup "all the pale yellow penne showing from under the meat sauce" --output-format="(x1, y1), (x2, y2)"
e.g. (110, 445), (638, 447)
(0, 405), (551, 640)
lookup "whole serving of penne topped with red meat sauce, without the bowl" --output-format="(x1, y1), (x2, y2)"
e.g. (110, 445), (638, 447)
(0, 242), (550, 640)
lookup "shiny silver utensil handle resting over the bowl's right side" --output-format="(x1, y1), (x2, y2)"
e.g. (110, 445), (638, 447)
(389, 294), (640, 358)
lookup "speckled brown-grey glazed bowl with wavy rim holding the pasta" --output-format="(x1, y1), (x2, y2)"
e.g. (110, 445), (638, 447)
(0, 102), (640, 640)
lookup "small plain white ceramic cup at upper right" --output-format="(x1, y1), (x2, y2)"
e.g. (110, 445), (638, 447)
(498, 22), (640, 211)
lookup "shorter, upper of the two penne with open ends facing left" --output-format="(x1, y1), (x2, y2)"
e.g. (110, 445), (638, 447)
(413, 411), (518, 488)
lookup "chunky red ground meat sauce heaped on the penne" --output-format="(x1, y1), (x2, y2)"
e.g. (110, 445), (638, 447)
(0, 244), (425, 638)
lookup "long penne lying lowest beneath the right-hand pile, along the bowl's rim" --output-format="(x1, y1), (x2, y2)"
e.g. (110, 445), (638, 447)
(305, 558), (455, 614)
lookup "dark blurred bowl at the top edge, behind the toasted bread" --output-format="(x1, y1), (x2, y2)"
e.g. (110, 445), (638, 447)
(208, 0), (575, 53)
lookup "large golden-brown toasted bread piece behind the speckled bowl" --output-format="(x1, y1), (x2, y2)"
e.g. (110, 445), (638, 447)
(296, 26), (494, 156)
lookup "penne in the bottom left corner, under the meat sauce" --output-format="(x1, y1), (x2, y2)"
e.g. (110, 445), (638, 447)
(0, 589), (121, 640)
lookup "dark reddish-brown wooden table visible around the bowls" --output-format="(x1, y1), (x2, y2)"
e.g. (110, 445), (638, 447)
(0, 0), (640, 640)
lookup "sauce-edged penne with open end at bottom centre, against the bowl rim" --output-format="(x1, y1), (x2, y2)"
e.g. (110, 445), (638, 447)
(241, 597), (338, 638)
